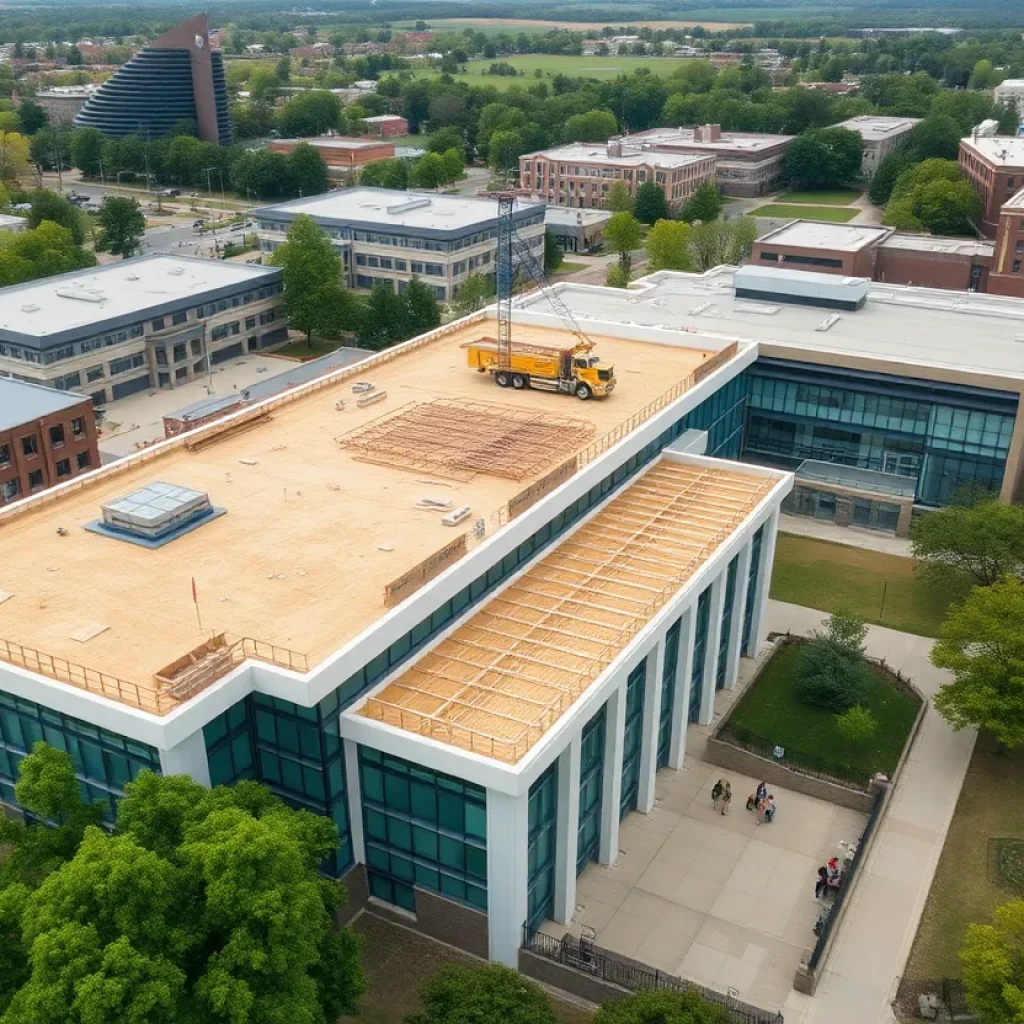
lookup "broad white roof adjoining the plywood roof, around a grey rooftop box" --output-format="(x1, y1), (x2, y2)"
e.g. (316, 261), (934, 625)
(516, 266), (1024, 390)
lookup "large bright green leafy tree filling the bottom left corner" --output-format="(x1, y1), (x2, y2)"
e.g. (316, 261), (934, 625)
(0, 748), (364, 1024)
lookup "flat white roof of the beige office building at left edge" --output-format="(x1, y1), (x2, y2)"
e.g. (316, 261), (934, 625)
(0, 256), (280, 337)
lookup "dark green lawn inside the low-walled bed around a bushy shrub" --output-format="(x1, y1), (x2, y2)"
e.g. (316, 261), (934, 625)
(729, 644), (921, 776)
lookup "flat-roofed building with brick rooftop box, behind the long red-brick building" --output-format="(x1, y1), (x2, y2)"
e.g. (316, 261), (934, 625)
(623, 125), (795, 197)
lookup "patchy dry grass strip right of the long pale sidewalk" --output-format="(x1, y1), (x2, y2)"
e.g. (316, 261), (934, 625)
(904, 732), (1024, 981)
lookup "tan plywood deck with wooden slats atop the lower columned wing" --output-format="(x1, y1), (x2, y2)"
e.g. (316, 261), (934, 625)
(360, 461), (776, 764)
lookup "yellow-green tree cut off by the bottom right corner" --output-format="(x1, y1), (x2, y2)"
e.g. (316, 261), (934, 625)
(959, 899), (1024, 1024)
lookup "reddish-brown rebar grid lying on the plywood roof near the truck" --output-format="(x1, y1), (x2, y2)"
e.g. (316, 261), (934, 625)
(337, 398), (596, 481)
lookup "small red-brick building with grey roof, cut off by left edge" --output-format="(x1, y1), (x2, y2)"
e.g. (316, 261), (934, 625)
(0, 377), (99, 507)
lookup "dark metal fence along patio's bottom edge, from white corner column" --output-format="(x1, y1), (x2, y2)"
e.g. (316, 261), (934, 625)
(522, 925), (784, 1024)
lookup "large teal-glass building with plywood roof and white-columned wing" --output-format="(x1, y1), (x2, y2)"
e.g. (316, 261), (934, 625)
(0, 308), (793, 966)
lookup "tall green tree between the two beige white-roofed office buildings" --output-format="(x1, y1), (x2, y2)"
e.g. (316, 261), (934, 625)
(269, 214), (358, 345)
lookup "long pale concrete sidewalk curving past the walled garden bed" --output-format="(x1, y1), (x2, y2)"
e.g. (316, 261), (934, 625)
(767, 601), (975, 1024)
